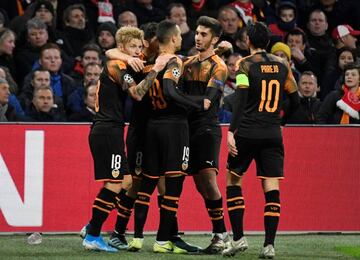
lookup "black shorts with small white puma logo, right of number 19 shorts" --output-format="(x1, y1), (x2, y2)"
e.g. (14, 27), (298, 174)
(187, 126), (221, 174)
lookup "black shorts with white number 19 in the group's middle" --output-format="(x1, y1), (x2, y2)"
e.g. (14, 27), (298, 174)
(144, 119), (189, 178)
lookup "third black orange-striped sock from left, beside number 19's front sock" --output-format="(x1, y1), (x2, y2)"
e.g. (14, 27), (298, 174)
(134, 176), (159, 238)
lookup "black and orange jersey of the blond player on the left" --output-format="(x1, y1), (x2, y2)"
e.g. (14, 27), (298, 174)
(94, 60), (129, 126)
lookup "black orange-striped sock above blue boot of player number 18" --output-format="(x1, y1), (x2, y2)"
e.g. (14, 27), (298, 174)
(88, 188), (117, 237)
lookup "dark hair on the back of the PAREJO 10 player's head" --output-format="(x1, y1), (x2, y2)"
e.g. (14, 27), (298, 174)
(246, 22), (270, 49)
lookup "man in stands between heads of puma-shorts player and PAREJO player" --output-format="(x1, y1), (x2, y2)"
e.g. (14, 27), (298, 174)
(217, 5), (241, 50)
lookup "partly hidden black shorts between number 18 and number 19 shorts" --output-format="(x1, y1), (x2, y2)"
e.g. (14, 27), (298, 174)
(126, 125), (146, 177)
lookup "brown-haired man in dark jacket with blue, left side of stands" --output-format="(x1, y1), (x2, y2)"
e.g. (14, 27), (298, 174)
(23, 43), (75, 114)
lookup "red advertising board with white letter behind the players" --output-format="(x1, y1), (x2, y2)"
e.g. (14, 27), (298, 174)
(0, 124), (360, 233)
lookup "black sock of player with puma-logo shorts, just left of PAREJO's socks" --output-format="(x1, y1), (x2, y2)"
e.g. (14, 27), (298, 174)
(205, 198), (226, 233)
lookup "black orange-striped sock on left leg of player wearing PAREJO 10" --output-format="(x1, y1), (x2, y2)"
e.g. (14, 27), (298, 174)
(226, 186), (245, 241)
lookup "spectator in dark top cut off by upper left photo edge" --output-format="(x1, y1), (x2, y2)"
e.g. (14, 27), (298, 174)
(0, 28), (17, 79)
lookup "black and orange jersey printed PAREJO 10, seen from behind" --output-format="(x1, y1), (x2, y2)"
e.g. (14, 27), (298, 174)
(237, 52), (297, 138)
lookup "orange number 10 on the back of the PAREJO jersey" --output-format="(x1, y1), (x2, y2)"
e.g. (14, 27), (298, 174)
(259, 79), (280, 113)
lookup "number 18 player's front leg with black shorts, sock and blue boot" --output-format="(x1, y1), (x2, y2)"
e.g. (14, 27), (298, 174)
(83, 126), (128, 252)
